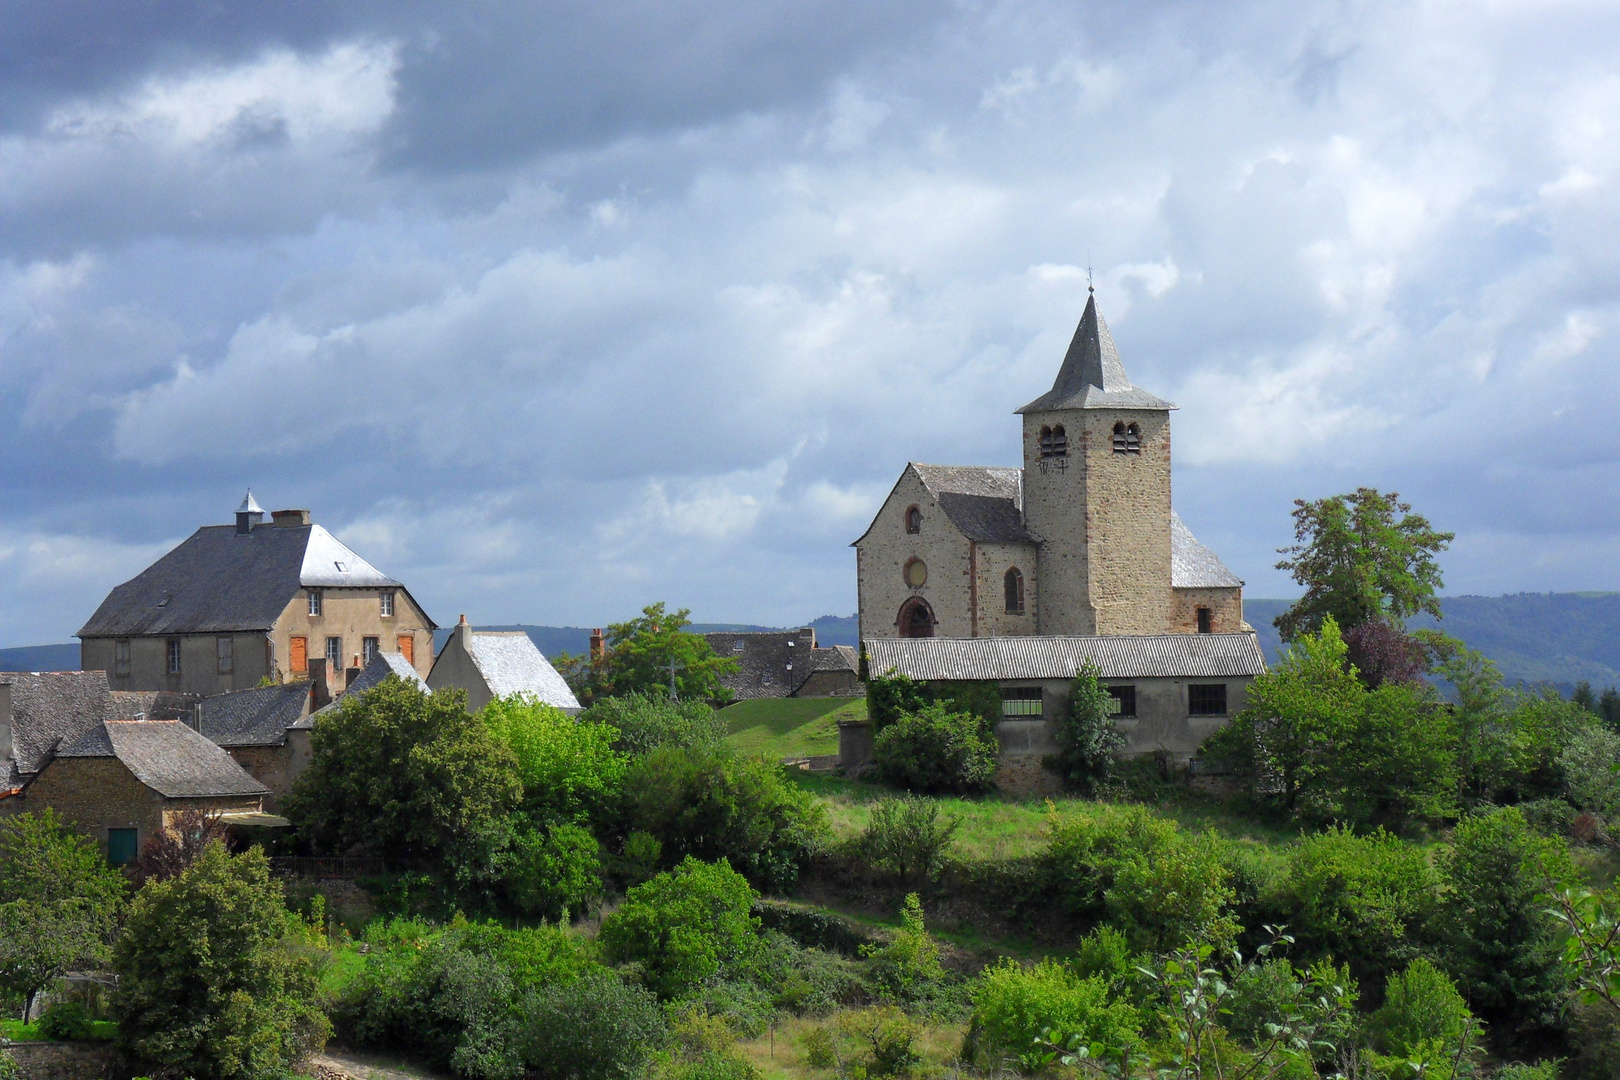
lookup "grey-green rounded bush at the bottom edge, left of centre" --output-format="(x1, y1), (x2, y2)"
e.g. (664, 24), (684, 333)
(523, 968), (664, 1080)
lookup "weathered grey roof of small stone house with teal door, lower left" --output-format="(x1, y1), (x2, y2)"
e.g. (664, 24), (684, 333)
(57, 721), (271, 798)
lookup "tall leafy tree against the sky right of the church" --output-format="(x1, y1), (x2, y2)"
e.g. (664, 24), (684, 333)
(1277, 487), (1455, 641)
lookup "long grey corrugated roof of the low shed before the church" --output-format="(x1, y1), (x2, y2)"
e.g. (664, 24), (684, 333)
(865, 631), (1265, 680)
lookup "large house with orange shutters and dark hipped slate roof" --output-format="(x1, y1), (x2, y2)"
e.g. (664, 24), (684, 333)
(78, 492), (434, 695)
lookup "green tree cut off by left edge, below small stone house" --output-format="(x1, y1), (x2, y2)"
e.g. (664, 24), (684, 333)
(0, 808), (128, 1020)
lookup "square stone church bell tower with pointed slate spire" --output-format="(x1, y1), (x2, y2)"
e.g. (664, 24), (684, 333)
(1017, 293), (1176, 635)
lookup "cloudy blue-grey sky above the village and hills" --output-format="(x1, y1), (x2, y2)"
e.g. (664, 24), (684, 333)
(0, 0), (1620, 646)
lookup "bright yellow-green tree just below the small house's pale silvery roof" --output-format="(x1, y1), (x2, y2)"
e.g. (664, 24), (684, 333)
(480, 695), (627, 824)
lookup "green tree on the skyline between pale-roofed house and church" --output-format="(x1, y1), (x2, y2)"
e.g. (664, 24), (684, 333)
(559, 601), (740, 704)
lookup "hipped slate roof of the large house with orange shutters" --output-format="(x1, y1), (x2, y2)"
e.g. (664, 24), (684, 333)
(76, 525), (431, 638)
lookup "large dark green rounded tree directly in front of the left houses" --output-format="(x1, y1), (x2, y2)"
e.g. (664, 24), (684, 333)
(284, 675), (523, 870)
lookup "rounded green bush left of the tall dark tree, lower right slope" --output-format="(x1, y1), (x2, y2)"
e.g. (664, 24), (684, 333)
(1278, 827), (1439, 983)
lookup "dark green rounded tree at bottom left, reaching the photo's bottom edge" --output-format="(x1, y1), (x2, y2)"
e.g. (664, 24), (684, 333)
(112, 844), (330, 1080)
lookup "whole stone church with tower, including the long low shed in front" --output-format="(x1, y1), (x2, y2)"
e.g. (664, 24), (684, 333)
(846, 295), (1265, 766)
